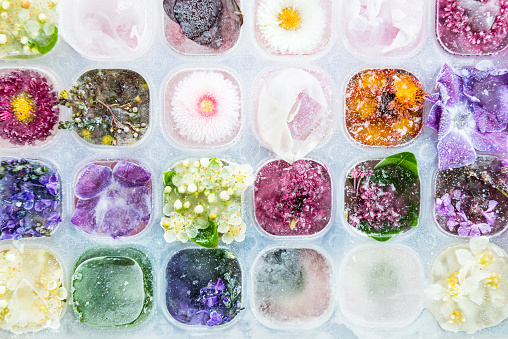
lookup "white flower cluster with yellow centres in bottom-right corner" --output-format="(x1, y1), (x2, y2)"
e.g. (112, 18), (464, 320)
(425, 237), (508, 333)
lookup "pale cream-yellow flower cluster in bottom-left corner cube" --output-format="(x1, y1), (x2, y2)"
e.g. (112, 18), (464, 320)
(0, 249), (67, 334)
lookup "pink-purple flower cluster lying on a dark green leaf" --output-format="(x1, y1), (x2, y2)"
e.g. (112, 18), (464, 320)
(349, 176), (408, 231)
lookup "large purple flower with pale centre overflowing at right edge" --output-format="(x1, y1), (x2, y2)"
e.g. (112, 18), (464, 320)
(427, 64), (508, 170)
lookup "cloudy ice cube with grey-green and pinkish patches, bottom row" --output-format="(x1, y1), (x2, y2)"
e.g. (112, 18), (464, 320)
(253, 248), (333, 328)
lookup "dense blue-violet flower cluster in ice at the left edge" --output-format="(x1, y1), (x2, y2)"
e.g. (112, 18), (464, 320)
(0, 159), (62, 240)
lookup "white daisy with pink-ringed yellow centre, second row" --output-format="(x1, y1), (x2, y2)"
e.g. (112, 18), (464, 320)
(171, 71), (241, 144)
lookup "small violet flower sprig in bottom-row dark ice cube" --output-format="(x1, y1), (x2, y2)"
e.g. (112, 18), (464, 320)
(197, 278), (241, 326)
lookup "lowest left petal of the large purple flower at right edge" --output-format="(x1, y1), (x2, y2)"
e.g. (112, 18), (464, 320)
(437, 131), (476, 170)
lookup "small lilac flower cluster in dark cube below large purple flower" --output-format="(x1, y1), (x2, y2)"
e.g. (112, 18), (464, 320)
(435, 189), (498, 237)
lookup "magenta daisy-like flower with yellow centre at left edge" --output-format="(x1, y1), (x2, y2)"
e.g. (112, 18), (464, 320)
(0, 70), (59, 145)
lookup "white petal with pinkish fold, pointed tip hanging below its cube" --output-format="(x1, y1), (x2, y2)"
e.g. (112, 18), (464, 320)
(257, 69), (331, 163)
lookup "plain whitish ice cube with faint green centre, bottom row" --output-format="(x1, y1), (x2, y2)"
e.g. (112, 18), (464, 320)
(339, 244), (424, 327)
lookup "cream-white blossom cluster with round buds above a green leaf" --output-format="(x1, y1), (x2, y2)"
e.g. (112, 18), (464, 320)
(161, 158), (254, 244)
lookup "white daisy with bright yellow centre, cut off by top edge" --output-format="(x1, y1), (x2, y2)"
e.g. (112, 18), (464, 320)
(257, 0), (326, 54)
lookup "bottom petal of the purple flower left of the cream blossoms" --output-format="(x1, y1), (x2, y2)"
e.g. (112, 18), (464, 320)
(102, 206), (141, 238)
